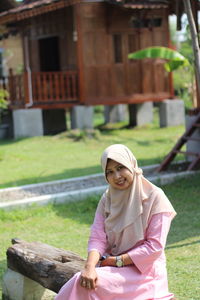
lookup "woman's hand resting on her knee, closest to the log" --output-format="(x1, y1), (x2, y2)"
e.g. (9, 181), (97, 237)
(80, 266), (97, 289)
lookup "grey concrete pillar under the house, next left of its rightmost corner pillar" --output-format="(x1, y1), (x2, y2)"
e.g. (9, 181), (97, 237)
(129, 102), (153, 126)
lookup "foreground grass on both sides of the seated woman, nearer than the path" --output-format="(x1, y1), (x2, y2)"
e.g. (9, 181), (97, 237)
(0, 174), (200, 300)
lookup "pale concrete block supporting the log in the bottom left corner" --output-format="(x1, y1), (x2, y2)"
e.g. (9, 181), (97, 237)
(2, 269), (56, 300)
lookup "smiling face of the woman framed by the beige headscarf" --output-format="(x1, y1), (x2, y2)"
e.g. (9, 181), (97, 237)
(106, 159), (133, 190)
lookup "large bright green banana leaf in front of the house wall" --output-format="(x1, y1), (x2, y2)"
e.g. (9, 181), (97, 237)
(128, 47), (189, 72)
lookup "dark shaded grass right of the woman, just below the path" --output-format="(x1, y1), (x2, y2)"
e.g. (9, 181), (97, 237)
(163, 174), (200, 248)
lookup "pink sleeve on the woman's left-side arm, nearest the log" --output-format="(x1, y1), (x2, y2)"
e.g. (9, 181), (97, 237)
(88, 212), (107, 255)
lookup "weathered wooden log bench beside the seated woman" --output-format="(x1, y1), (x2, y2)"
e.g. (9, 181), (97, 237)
(7, 239), (85, 293)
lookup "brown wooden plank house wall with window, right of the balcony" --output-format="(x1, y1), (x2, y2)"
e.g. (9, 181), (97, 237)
(78, 3), (169, 104)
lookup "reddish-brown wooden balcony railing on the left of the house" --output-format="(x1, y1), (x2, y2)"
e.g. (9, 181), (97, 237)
(0, 71), (79, 109)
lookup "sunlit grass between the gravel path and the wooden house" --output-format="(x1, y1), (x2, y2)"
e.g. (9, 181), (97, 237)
(0, 108), (184, 188)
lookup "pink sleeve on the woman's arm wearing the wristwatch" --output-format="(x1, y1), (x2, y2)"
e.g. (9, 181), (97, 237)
(128, 213), (171, 273)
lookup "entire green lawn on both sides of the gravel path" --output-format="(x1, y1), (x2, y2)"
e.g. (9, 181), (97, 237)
(0, 110), (197, 300)
